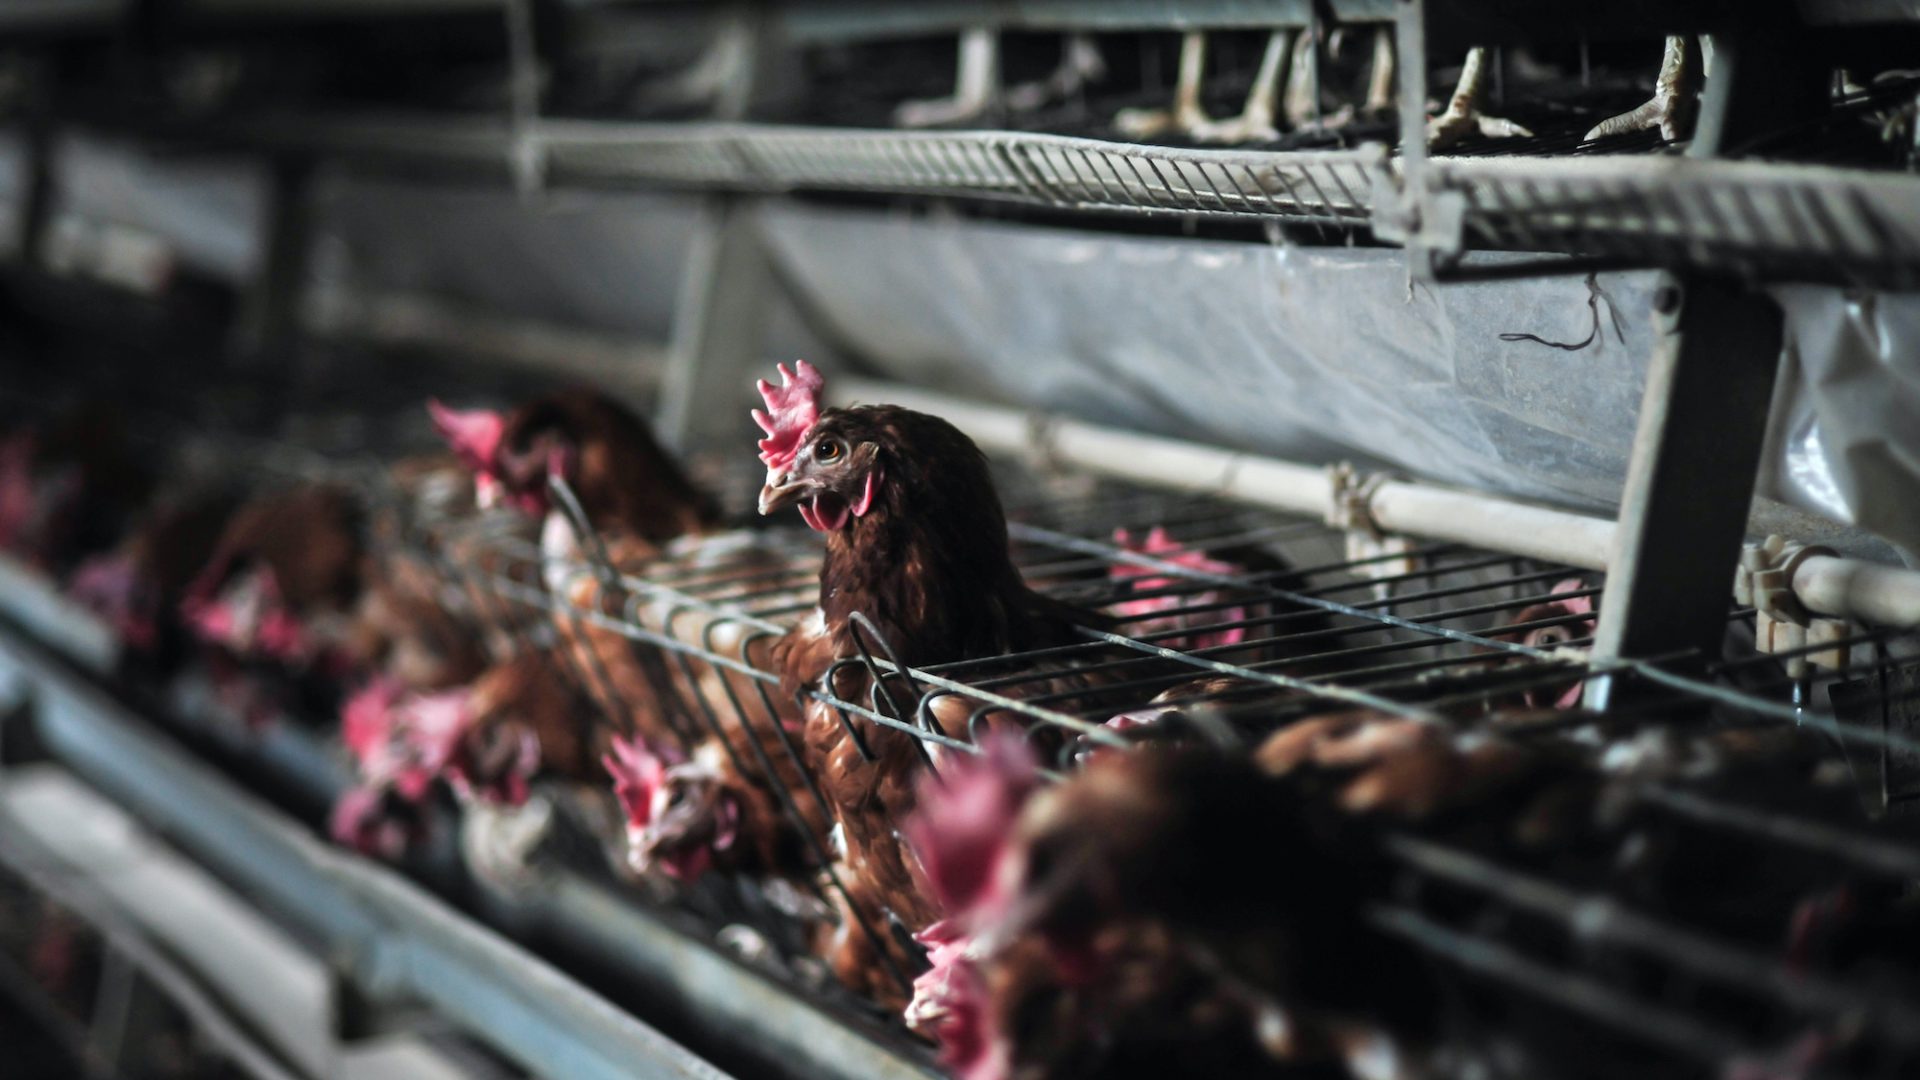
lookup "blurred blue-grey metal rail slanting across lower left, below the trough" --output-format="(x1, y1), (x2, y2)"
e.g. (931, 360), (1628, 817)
(0, 599), (722, 1080)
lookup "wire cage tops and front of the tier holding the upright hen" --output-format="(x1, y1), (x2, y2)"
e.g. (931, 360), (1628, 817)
(322, 438), (1896, 1072)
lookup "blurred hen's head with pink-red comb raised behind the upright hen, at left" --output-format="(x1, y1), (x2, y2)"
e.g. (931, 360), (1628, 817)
(426, 400), (564, 517)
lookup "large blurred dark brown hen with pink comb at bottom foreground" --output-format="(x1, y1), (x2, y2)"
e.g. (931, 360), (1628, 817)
(910, 730), (1411, 1080)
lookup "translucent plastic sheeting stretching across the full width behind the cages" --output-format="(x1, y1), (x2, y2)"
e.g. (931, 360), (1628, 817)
(33, 140), (1920, 552)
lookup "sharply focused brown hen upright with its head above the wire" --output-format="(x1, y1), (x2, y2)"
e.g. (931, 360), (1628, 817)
(755, 361), (1104, 1009)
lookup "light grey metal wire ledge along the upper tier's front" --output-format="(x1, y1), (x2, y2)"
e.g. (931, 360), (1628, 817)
(37, 107), (1920, 288)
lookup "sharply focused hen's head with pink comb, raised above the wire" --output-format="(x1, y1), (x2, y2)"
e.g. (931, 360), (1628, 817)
(753, 359), (1006, 548)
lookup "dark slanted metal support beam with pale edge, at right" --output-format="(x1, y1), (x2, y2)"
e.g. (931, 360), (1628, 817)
(1586, 275), (1782, 709)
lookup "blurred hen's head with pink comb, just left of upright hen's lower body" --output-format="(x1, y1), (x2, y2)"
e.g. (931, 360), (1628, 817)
(603, 738), (739, 882)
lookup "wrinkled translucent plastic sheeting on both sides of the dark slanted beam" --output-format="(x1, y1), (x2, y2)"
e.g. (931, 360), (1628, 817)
(768, 206), (1920, 550)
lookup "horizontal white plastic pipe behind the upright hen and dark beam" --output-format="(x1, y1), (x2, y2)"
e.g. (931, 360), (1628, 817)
(829, 379), (1920, 626)
